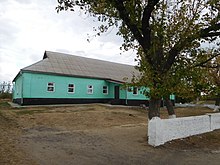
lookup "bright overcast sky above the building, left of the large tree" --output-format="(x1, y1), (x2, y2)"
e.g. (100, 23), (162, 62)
(0, 0), (136, 82)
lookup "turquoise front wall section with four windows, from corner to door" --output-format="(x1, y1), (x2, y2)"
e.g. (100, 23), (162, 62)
(23, 73), (117, 98)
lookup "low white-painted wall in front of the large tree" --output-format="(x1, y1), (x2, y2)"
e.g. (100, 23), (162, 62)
(148, 113), (220, 146)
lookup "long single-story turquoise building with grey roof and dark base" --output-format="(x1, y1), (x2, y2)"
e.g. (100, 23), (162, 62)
(13, 51), (174, 105)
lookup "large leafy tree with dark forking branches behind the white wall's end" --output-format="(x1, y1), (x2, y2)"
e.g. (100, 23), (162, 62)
(57, 0), (220, 119)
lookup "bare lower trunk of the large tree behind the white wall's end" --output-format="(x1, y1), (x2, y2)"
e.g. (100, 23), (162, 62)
(148, 98), (161, 119)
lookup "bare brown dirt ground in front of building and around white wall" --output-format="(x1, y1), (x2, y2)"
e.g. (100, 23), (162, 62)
(0, 100), (220, 165)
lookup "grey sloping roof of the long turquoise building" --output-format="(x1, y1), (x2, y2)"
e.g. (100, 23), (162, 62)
(21, 51), (139, 82)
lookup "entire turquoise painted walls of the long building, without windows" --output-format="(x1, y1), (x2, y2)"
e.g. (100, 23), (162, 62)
(13, 72), (150, 103)
